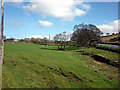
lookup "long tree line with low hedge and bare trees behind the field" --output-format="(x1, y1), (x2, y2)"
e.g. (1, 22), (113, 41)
(4, 23), (110, 50)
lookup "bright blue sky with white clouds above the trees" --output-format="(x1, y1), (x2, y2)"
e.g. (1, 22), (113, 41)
(0, 0), (119, 39)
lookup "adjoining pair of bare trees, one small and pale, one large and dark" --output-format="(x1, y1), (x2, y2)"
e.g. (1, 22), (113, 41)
(54, 23), (103, 50)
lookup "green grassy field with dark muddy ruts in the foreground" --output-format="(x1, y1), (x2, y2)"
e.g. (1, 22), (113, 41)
(2, 43), (118, 88)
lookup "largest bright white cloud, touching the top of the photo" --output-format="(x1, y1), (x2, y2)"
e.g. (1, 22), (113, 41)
(23, 0), (90, 20)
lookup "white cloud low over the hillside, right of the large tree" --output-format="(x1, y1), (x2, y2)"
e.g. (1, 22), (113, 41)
(97, 20), (120, 34)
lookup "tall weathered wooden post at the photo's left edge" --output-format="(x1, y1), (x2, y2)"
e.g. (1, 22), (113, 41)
(1, 0), (4, 64)
